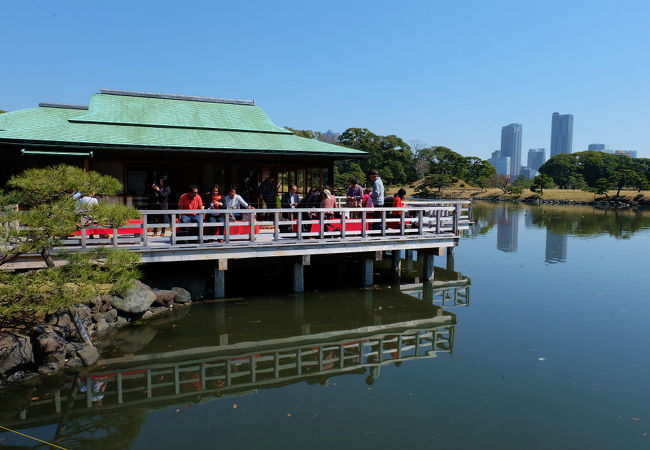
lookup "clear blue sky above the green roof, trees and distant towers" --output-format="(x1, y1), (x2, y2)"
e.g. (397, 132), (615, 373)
(0, 0), (650, 159)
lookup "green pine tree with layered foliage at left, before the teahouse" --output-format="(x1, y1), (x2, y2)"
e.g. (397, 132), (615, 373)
(0, 165), (140, 320)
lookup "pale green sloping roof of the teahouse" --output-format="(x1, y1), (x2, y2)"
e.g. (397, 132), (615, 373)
(0, 91), (365, 157)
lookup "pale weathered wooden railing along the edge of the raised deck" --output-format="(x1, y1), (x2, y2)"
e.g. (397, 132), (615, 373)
(64, 201), (471, 248)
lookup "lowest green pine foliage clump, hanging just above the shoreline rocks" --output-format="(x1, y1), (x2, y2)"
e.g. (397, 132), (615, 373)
(0, 249), (140, 317)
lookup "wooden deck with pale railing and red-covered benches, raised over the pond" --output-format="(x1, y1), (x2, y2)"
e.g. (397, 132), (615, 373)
(3, 201), (471, 270)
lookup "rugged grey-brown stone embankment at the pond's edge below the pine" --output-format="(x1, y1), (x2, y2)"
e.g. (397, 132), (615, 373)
(0, 281), (191, 385)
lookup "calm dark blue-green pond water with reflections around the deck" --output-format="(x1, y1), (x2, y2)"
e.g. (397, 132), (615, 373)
(0, 202), (650, 450)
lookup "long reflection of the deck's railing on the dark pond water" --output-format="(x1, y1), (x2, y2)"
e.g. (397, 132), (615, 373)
(3, 315), (455, 427)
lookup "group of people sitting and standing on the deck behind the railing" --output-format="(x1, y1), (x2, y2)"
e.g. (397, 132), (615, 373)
(150, 170), (406, 236)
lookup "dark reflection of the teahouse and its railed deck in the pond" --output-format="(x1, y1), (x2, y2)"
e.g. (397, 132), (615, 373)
(0, 269), (469, 448)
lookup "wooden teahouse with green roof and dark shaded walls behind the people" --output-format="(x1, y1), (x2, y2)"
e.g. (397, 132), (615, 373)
(0, 89), (365, 208)
